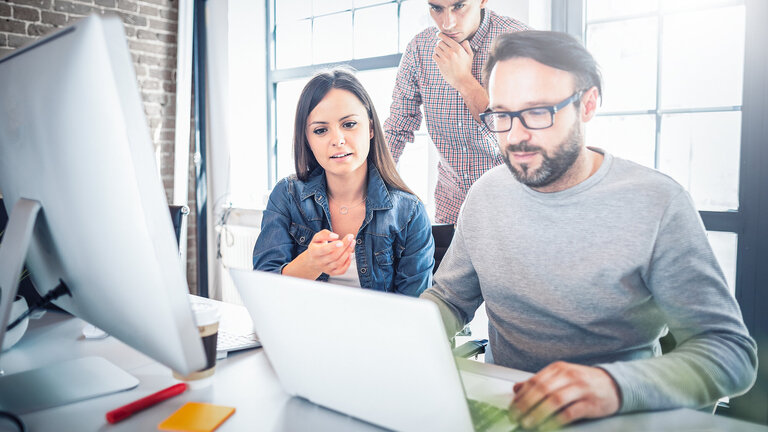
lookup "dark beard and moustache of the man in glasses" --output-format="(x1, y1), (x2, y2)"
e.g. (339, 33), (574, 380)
(501, 120), (583, 188)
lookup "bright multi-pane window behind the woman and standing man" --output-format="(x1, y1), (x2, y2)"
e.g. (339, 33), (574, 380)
(268, 0), (437, 208)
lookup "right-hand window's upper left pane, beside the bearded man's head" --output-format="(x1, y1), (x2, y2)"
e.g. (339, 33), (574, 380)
(587, 18), (658, 111)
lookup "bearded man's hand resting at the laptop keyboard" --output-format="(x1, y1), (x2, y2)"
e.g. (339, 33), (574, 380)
(509, 362), (620, 430)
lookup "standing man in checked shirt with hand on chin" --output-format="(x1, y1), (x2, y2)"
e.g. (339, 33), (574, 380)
(384, 0), (527, 224)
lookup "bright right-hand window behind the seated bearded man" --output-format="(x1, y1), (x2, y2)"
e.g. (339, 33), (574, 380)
(583, 0), (746, 289)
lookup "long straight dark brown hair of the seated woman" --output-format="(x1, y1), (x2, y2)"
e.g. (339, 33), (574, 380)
(293, 67), (415, 195)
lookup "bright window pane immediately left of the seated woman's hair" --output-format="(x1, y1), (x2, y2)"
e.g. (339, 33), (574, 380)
(275, 78), (309, 180)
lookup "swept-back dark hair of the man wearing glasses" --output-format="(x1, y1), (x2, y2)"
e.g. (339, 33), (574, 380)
(483, 30), (603, 100)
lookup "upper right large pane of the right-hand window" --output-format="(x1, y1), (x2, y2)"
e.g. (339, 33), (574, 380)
(661, 6), (744, 108)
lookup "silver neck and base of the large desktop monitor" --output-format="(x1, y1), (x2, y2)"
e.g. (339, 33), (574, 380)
(0, 198), (139, 414)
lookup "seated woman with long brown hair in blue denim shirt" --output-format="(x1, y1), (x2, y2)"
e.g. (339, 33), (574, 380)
(253, 68), (434, 296)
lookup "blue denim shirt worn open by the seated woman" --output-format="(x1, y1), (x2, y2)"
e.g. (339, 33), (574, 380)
(253, 164), (435, 296)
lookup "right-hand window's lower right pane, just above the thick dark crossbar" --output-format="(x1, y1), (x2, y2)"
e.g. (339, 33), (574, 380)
(659, 111), (741, 211)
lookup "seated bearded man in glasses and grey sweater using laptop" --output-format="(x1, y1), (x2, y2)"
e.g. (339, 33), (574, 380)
(422, 31), (757, 429)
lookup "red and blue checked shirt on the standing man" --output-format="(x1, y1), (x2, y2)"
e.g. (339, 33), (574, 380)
(384, 9), (528, 224)
